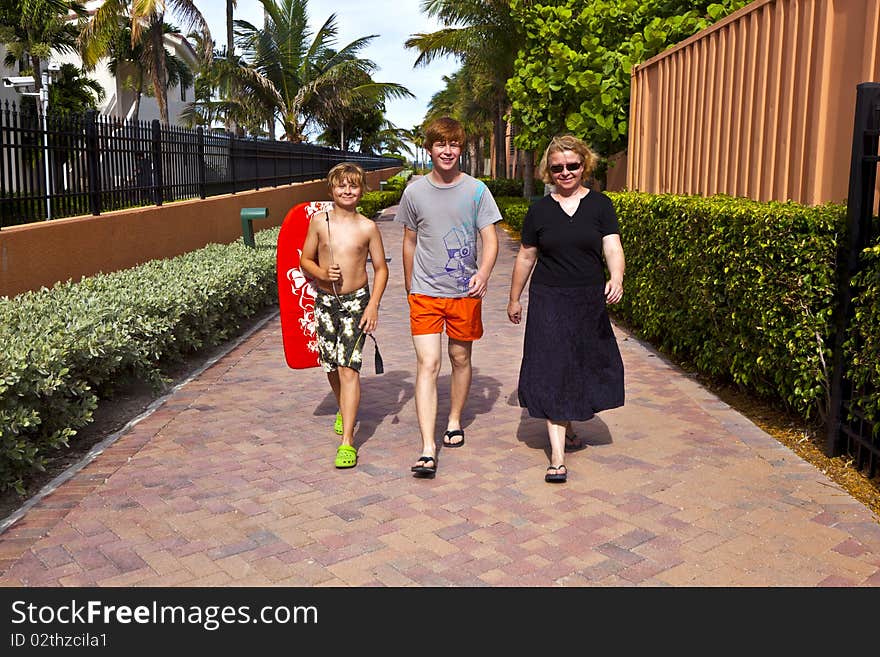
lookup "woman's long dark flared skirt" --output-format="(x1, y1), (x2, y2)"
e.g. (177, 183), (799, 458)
(519, 283), (624, 422)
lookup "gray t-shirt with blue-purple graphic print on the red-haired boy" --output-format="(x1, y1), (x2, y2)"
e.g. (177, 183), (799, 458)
(394, 173), (501, 298)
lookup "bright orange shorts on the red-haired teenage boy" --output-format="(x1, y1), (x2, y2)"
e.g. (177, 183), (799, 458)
(407, 294), (483, 342)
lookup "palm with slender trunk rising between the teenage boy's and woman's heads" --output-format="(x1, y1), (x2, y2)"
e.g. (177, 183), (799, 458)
(405, 0), (522, 178)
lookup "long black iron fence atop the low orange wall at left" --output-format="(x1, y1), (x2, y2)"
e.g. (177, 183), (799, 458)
(0, 101), (400, 228)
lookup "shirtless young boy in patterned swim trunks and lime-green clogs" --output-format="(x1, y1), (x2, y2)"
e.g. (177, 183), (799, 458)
(300, 162), (388, 468)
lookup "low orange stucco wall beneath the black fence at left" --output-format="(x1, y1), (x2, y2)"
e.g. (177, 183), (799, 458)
(0, 168), (400, 296)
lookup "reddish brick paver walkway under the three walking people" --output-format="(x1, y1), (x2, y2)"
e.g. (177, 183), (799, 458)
(0, 205), (880, 586)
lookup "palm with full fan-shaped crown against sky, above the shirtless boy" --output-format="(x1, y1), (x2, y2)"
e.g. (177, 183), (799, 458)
(229, 0), (412, 142)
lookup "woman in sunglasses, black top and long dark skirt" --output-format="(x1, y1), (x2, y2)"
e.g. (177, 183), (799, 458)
(507, 135), (624, 483)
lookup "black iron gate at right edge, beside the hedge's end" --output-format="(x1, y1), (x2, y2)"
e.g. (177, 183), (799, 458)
(826, 83), (880, 477)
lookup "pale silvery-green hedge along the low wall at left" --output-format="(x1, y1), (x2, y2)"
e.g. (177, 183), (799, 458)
(0, 228), (278, 492)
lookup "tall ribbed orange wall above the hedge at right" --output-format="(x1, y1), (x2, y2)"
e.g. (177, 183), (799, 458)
(627, 0), (880, 205)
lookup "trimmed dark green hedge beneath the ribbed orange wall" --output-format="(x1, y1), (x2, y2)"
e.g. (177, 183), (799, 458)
(609, 192), (846, 416)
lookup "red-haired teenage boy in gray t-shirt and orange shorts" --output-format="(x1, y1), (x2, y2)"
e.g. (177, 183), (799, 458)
(395, 117), (501, 477)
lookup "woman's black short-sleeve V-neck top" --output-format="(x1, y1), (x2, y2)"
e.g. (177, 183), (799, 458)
(521, 190), (620, 287)
